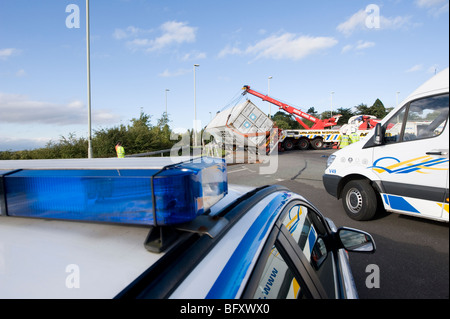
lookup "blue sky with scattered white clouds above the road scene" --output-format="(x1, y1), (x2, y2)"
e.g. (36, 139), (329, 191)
(0, 0), (449, 151)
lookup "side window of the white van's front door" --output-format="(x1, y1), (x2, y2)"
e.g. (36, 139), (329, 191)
(384, 94), (449, 144)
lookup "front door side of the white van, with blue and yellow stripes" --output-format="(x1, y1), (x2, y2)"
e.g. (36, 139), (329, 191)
(372, 93), (449, 220)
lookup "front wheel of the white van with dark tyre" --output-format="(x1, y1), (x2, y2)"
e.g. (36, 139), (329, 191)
(342, 180), (377, 220)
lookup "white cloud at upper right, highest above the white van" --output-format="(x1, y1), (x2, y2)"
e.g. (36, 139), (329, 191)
(336, 10), (412, 36)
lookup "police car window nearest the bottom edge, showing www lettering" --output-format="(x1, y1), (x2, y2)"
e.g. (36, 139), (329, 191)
(253, 247), (303, 299)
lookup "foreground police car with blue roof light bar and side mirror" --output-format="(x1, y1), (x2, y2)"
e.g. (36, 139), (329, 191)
(0, 158), (375, 299)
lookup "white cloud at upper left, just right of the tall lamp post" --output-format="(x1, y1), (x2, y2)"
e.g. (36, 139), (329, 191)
(118, 21), (198, 52)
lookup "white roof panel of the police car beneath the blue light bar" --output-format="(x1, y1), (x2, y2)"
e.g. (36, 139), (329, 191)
(0, 182), (255, 299)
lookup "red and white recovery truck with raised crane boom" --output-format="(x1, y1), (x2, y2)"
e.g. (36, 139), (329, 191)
(243, 85), (380, 150)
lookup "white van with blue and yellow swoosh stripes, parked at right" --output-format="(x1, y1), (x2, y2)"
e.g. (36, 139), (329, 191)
(323, 68), (449, 222)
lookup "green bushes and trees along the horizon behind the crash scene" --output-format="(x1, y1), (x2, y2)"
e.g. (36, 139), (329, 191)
(0, 99), (390, 160)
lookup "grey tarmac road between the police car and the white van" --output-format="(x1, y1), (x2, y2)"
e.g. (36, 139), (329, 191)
(228, 150), (449, 299)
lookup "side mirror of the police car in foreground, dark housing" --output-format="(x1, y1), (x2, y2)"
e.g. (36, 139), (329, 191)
(337, 227), (376, 253)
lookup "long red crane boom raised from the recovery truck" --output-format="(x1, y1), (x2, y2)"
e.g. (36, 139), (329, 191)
(243, 85), (340, 130)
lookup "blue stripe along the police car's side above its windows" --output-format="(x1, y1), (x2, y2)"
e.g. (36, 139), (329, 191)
(206, 193), (291, 299)
